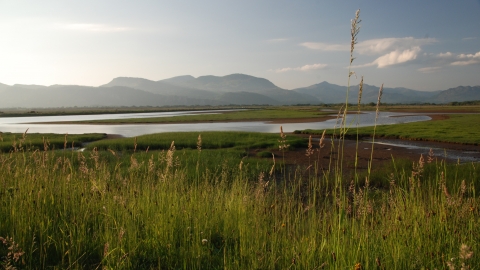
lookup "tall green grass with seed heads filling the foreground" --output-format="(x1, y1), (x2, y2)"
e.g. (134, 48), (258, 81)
(0, 9), (480, 269)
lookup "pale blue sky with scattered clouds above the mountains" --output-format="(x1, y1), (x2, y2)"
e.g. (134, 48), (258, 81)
(0, 0), (480, 91)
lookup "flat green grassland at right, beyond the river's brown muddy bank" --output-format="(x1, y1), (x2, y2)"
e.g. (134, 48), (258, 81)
(295, 114), (480, 145)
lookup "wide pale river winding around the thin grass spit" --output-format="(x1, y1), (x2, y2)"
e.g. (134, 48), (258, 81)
(0, 111), (431, 137)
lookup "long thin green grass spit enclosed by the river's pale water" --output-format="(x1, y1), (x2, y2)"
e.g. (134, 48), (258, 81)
(68, 106), (331, 124)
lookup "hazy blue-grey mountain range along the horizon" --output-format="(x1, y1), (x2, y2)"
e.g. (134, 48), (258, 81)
(0, 74), (480, 108)
